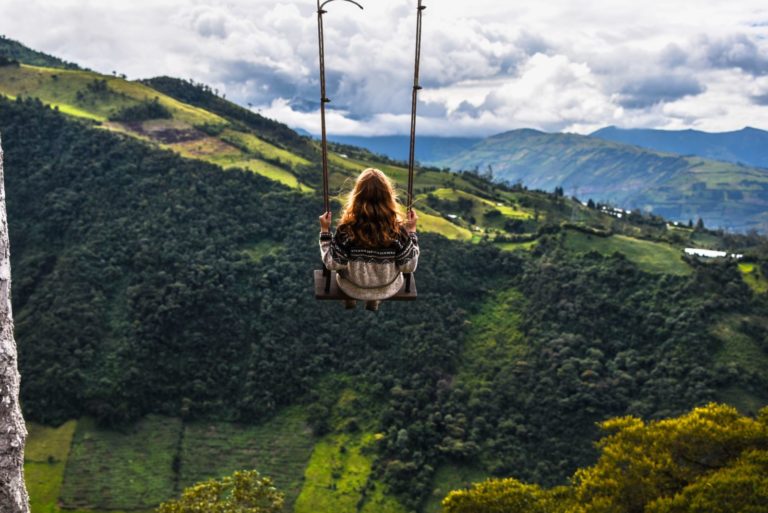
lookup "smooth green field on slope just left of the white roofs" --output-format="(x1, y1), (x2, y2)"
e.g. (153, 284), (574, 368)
(565, 230), (691, 275)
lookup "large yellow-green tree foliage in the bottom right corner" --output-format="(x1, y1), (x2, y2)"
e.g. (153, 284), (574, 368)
(443, 404), (768, 513)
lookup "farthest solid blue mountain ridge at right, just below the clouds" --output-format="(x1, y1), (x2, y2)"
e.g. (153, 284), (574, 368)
(590, 126), (768, 168)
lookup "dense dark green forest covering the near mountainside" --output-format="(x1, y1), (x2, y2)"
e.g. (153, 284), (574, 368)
(0, 95), (768, 509)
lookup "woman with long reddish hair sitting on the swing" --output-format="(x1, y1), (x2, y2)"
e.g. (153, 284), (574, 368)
(320, 169), (419, 312)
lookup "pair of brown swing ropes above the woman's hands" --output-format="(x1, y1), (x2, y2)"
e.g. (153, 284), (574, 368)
(317, 0), (427, 213)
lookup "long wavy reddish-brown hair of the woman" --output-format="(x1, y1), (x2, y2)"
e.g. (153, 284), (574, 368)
(339, 168), (402, 248)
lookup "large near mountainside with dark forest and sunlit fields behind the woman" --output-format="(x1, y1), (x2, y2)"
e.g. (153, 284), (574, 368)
(0, 36), (768, 513)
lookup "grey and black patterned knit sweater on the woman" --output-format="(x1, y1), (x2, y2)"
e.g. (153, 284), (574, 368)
(320, 230), (419, 300)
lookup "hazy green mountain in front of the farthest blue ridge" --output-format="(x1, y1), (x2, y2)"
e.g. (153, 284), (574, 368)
(439, 129), (768, 233)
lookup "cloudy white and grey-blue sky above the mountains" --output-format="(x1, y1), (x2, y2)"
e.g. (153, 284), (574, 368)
(0, 0), (768, 136)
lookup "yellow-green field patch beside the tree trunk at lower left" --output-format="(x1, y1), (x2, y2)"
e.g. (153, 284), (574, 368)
(24, 420), (77, 513)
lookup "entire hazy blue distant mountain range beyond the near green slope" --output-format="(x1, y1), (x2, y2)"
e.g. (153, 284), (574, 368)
(331, 127), (768, 231)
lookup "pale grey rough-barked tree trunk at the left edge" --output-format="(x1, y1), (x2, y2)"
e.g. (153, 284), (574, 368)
(0, 136), (29, 513)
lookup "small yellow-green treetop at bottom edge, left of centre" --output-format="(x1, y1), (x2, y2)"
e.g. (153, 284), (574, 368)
(157, 470), (285, 513)
